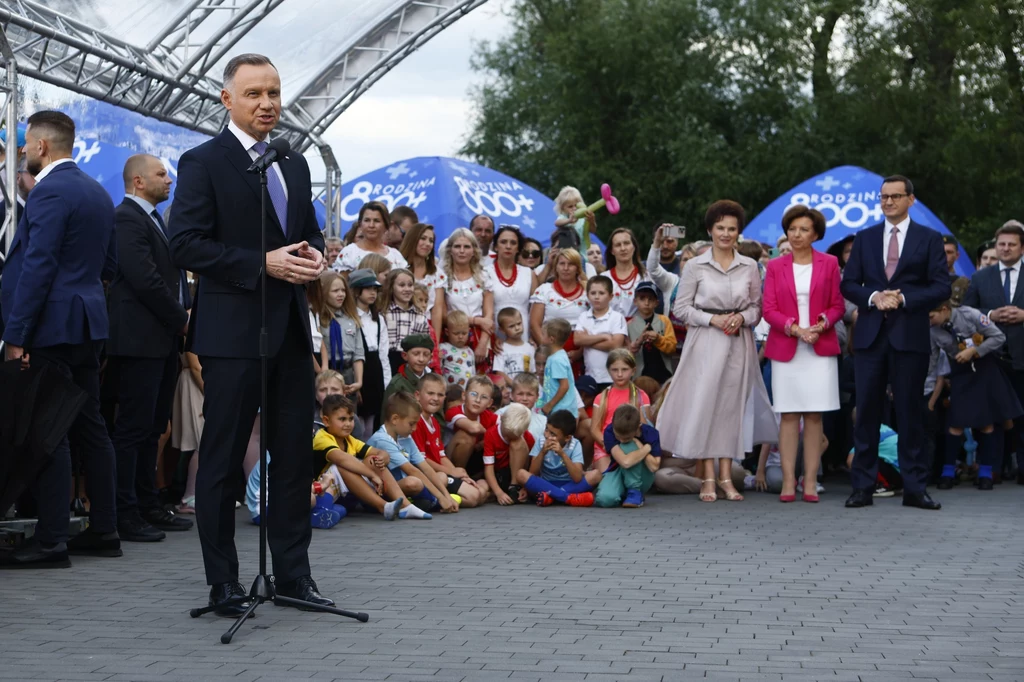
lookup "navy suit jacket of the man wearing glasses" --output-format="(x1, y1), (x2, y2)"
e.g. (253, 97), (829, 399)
(840, 220), (950, 353)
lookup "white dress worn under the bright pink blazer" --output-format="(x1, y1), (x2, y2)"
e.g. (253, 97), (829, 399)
(771, 263), (839, 413)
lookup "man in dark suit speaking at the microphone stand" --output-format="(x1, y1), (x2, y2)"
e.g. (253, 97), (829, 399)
(170, 54), (334, 616)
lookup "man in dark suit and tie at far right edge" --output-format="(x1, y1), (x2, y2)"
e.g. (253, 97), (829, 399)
(964, 220), (1024, 485)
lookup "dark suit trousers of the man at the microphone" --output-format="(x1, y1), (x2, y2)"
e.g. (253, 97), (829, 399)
(196, 311), (314, 585)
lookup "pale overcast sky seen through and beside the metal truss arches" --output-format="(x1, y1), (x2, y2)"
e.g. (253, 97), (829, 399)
(44, 0), (513, 180)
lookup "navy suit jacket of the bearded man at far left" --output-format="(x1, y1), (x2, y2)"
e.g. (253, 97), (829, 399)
(0, 162), (117, 349)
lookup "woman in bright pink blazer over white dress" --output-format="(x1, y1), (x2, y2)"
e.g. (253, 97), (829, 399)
(763, 205), (846, 502)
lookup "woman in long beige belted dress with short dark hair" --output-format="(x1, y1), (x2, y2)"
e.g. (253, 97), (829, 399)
(658, 196), (778, 502)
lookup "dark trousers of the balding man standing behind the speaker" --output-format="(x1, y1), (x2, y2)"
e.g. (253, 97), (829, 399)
(111, 352), (181, 519)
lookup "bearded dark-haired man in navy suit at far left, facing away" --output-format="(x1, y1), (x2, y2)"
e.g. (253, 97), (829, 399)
(0, 112), (121, 567)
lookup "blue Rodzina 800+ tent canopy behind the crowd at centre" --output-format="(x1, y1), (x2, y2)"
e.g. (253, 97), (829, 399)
(331, 157), (601, 248)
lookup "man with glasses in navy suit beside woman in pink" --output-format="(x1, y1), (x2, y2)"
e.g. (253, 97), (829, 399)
(841, 175), (950, 509)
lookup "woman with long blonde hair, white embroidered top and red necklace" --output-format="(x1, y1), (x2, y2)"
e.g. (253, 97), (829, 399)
(435, 227), (495, 364)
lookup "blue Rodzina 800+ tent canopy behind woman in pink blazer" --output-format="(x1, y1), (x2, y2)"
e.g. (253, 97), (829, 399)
(743, 166), (975, 276)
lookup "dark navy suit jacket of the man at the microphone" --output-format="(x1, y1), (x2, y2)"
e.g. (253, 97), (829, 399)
(168, 129), (324, 359)
